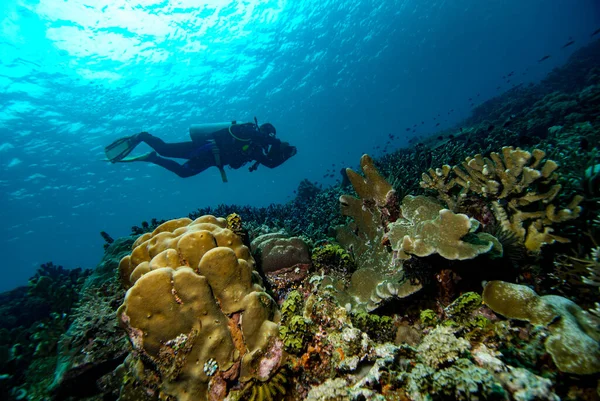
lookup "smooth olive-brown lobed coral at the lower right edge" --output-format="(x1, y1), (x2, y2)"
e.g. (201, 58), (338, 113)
(483, 281), (600, 375)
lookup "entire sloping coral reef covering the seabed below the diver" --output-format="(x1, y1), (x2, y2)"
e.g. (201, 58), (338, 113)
(0, 36), (600, 401)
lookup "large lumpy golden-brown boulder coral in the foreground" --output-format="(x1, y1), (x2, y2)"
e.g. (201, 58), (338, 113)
(117, 216), (284, 401)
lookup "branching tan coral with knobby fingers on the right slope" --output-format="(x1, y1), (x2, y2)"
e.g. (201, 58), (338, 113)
(421, 146), (583, 252)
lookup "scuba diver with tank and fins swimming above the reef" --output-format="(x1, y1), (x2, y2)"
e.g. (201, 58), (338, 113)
(104, 117), (296, 182)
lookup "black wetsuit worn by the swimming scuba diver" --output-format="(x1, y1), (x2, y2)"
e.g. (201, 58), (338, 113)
(138, 123), (287, 178)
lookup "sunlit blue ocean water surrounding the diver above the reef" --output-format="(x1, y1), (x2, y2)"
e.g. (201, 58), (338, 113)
(0, 0), (600, 291)
